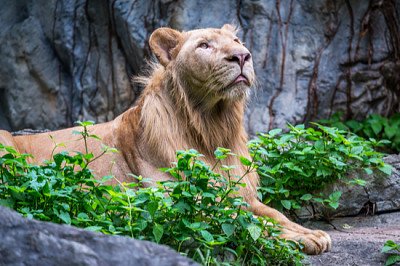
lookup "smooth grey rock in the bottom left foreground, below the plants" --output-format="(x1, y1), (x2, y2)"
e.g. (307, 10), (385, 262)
(0, 206), (198, 266)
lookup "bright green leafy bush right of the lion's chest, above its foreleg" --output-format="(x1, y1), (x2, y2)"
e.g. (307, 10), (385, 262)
(249, 123), (391, 216)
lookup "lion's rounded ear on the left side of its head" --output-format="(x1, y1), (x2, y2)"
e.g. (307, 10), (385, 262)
(149, 28), (182, 66)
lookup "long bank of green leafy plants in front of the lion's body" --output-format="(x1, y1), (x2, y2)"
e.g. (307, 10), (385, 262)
(0, 122), (305, 265)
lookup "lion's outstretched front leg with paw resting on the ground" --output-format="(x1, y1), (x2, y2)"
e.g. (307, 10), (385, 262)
(249, 197), (332, 255)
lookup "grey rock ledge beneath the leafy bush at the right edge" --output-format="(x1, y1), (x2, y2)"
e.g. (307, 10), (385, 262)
(299, 154), (400, 217)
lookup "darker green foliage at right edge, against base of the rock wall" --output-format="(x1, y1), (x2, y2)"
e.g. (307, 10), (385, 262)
(320, 112), (400, 153)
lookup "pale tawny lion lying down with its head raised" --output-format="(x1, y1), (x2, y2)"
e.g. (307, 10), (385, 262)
(0, 24), (331, 254)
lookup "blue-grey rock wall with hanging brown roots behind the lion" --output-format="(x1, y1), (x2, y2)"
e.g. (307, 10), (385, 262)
(0, 0), (400, 135)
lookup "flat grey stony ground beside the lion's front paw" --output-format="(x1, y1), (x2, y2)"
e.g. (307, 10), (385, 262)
(304, 212), (400, 266)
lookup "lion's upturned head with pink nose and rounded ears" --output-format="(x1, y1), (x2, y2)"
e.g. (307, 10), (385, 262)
(150, 24), (255, 105)
